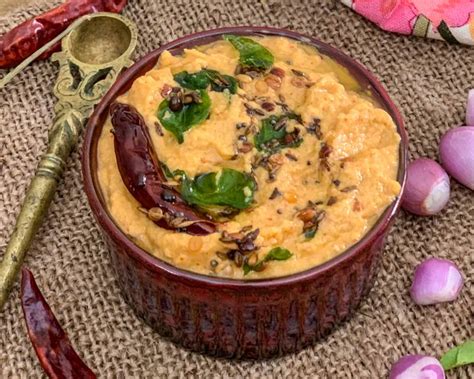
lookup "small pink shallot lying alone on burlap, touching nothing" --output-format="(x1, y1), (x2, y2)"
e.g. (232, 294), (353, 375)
(410, 258), (464, 305)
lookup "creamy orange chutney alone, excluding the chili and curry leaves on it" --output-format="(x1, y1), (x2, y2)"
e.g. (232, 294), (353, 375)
(98, 37), (400, 279)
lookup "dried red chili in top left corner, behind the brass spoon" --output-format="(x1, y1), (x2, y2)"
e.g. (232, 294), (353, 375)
(0, 0), (127, 69)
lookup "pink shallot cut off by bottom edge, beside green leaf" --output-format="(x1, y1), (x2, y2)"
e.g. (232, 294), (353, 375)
(389, 355), (446, 379)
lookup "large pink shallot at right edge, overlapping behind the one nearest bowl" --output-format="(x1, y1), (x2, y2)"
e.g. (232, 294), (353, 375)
(439, 127), (474, 190)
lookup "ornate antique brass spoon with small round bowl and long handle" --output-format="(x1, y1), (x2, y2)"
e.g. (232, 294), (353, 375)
(0, 13), (137, 309)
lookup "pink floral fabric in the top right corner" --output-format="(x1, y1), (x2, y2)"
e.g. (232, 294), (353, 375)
(341, 0), (474, 45)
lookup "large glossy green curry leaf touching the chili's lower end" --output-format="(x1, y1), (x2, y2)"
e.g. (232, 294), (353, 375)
(181, 168), (256, 210)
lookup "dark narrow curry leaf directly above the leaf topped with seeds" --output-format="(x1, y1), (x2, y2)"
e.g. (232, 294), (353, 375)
(173, 69), (237, 94)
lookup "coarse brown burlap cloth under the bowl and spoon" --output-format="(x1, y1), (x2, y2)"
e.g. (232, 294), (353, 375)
(0, 0), (474, 379)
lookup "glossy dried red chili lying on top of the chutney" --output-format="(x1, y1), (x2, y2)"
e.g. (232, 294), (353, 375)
(110, 103), (216, 235)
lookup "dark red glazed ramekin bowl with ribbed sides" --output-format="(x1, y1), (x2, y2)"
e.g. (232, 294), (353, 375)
(82, 27), (408, 359)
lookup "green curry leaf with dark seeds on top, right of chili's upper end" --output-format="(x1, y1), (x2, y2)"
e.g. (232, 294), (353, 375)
(157, 90), (211, 143)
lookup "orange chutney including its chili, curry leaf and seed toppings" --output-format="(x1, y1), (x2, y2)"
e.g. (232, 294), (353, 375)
(98, 36), (400, 279)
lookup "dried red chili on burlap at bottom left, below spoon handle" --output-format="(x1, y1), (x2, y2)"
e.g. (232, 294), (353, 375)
(21, 267), (96, 379)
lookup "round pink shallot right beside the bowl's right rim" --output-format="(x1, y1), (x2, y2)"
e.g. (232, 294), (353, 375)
(402, 158), (451, 216)
